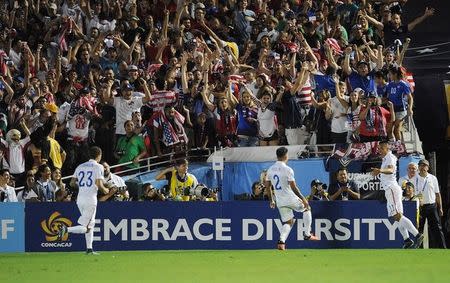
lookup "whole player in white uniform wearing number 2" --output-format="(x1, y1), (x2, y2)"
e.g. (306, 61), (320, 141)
(264, 147), (318, 250)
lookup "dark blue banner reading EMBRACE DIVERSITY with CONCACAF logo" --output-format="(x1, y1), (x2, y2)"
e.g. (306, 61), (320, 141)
(26, 201), (416, 252)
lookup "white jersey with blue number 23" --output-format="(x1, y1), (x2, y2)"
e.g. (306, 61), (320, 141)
(74, 159), (104, 204)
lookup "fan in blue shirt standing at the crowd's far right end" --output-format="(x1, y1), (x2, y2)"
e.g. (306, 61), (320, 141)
(386, 66), (413, 140)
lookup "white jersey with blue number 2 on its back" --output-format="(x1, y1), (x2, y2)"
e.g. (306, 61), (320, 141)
(266, 161), (299, 207)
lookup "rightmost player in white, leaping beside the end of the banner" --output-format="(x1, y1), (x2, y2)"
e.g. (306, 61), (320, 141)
(372, 141), (423, 249)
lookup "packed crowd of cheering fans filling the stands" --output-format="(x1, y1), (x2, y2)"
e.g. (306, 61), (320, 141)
(0, 0), (434, 201)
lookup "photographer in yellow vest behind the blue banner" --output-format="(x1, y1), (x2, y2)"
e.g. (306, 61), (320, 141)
(156, 159), (198, 201)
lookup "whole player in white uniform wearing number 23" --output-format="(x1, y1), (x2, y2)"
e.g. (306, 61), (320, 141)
(58, 146), (109, 255)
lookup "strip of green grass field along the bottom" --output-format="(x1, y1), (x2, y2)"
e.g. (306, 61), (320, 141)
(0, 250), (450, 283)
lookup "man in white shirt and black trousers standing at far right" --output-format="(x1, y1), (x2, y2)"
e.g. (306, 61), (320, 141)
(414, 159), (446, 249)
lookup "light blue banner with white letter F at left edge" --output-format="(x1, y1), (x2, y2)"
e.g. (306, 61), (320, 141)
(0, 202), (25, 252)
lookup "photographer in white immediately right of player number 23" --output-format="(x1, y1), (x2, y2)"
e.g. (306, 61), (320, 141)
(98, 162), (130, 201)
